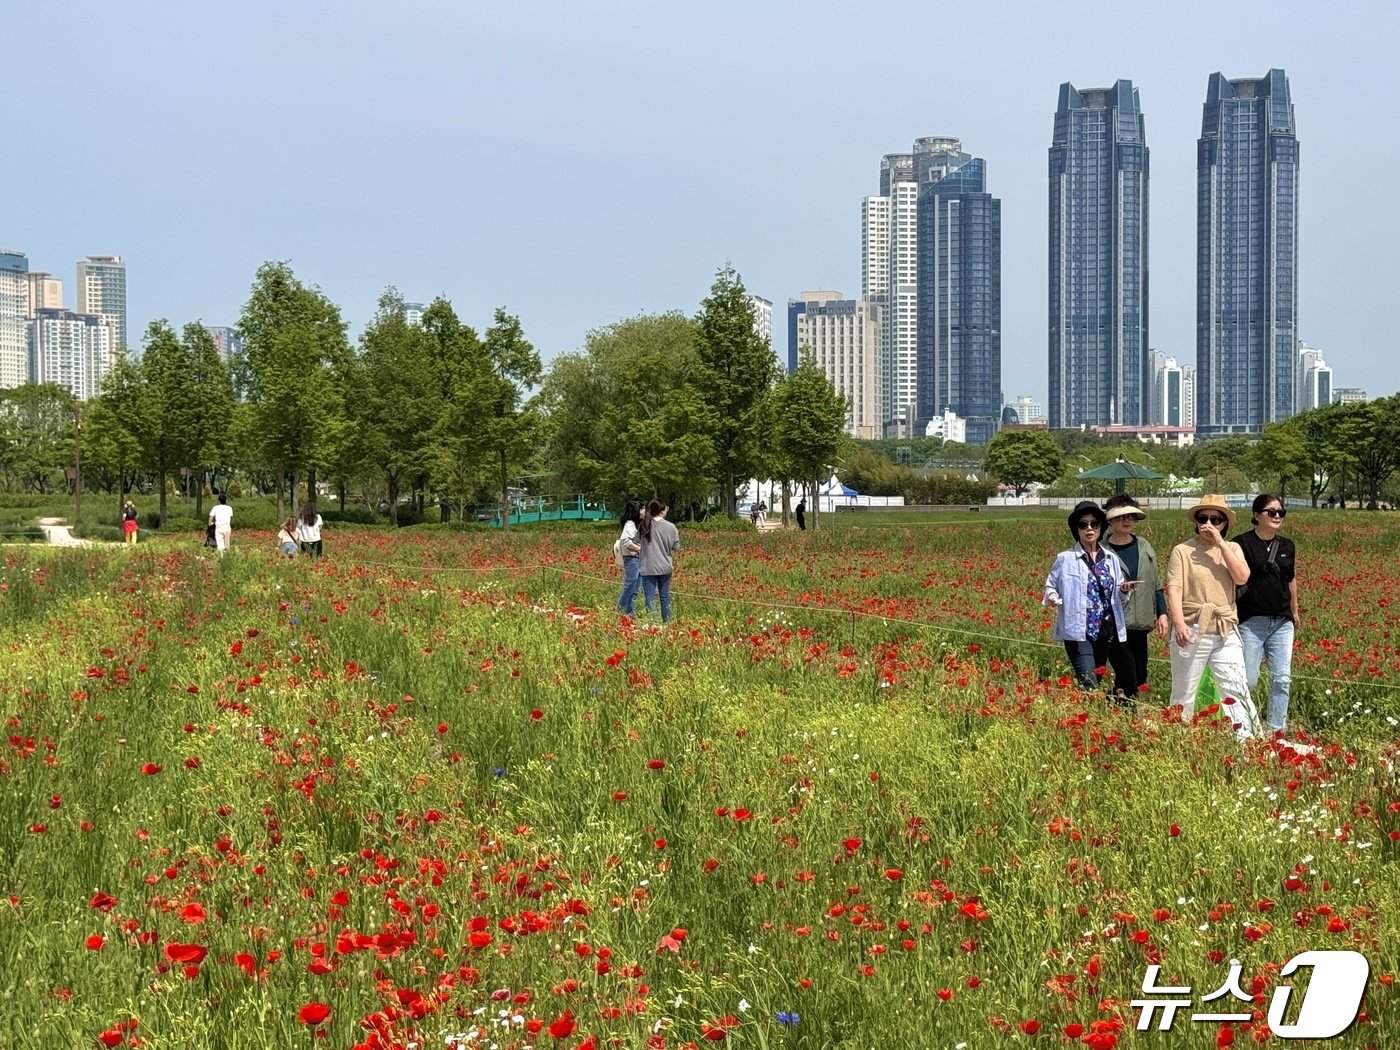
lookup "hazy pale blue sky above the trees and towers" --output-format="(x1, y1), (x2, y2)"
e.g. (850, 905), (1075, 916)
(0, 0), (1400, 399)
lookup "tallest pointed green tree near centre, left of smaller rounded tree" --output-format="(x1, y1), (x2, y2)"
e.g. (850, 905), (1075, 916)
(696, 266), (776, 518)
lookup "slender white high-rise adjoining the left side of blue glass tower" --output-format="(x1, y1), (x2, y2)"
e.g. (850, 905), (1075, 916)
(861, 153), (918, 437)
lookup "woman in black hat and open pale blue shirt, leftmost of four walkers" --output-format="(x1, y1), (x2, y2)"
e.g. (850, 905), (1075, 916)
(1042, 500), (1133, 694)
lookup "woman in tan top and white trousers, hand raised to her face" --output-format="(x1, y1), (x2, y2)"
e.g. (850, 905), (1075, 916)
(1166, 496), (1259, 741)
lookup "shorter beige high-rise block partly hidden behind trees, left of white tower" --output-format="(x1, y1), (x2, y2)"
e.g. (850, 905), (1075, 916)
(787, 291), (883, 438)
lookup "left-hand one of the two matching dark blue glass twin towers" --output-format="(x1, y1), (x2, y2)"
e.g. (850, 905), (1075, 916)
(1049, 80), (1149, 427)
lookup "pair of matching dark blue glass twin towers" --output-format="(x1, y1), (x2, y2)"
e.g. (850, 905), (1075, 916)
(1047, 69), (1298, 437)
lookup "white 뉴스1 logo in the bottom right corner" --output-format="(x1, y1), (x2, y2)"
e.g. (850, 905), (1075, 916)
(1131, 952), (1371, 1039)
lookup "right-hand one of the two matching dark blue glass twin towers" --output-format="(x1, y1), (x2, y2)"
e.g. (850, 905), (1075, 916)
(1196, 69), (1298, 437)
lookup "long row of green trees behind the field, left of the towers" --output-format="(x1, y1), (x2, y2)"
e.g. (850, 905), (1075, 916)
(0, 263), (847, 521)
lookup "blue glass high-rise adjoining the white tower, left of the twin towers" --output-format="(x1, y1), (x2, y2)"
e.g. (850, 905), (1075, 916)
(914, 137), (1001, 445)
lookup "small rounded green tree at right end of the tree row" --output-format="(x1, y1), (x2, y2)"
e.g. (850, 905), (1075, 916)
(771, 354), (850, 531)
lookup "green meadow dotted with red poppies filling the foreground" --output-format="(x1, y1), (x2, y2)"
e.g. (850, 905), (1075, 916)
(0, 512), (1400, 1050)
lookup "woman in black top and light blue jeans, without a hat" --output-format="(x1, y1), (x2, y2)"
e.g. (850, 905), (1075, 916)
(1235, 493), (1298, 732)
